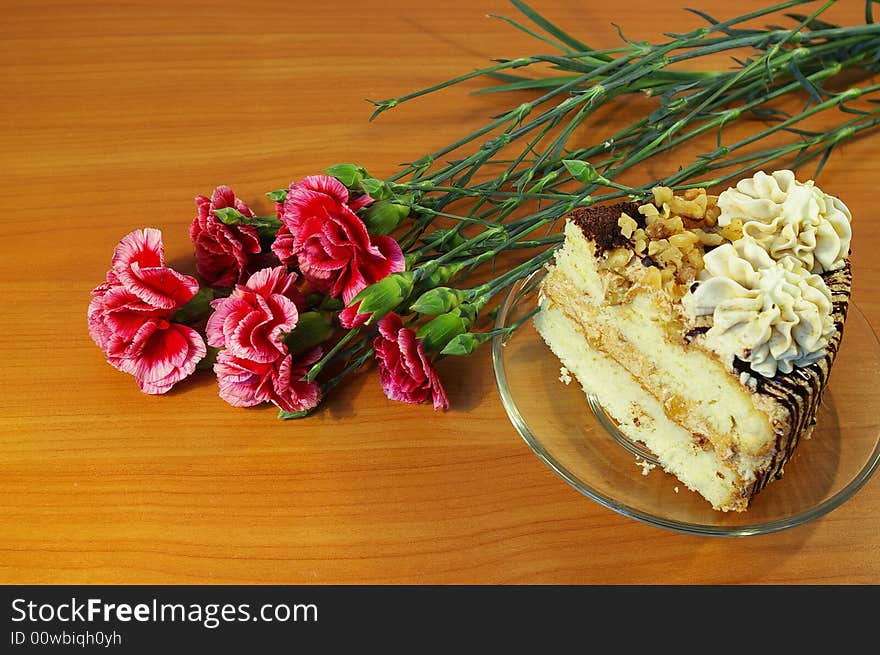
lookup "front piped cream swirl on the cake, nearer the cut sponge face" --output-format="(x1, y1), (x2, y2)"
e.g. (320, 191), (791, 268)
(685, 236), (835, 377)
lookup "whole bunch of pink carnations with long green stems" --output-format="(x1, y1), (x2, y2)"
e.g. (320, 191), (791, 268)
(88, 0), (880, 418)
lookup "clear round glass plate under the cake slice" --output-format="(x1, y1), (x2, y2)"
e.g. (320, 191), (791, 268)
(492, 271), (880, 536)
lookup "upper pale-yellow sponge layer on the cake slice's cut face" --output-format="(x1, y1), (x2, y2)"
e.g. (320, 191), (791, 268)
(544, 225), (775, 458)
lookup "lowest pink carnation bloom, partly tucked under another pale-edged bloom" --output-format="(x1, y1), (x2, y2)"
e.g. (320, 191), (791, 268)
(214, 348), (322, 412)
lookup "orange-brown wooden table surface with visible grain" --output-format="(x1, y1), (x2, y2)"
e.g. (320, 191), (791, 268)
(0, 0), (880, 584)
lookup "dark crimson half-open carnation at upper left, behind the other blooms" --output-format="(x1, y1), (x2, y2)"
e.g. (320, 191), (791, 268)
(189, 186), (260, 287)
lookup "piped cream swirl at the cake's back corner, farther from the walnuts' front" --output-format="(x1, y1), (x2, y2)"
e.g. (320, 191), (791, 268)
(718, 170), (852, 273)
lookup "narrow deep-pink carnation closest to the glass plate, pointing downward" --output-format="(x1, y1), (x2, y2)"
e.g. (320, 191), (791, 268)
(373, 312), (449, 410)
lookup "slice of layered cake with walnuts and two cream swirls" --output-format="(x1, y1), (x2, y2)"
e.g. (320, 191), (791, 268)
(535, 171), (851, 511)
